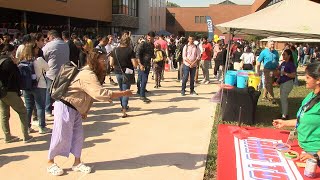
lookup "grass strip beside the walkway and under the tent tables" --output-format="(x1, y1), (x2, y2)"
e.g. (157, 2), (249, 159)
(204, 69), (310, 180)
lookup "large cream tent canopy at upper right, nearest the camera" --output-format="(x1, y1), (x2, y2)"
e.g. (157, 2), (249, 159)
(216, 0), (320, 38)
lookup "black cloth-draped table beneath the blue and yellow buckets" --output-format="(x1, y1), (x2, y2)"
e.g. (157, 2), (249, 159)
(221, 87), (261, 124)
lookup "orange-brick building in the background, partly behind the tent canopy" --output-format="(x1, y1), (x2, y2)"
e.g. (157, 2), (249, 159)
(167, 0), (320, 36)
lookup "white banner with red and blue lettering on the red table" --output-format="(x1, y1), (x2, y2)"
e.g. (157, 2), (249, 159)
(234, 137), (303, 180)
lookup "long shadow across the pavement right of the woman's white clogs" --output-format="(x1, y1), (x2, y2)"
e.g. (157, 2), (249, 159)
(87, 153), (207, 171)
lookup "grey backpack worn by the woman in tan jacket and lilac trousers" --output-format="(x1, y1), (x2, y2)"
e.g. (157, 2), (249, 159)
(50, 61), (79, 101)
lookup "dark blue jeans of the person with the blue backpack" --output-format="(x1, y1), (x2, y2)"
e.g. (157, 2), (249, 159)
(23, 88), (46, 128)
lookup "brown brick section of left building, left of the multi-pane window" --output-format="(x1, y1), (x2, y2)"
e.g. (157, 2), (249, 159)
(0, 0), (112, 34)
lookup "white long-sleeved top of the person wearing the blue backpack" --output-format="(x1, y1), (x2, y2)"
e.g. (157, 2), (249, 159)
(33, 57), (49, 88)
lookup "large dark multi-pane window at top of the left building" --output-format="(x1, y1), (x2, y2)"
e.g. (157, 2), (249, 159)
(112, 0), (138, 17)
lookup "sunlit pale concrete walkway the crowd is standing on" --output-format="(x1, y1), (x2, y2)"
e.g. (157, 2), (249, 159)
(0, 72), (217, 180)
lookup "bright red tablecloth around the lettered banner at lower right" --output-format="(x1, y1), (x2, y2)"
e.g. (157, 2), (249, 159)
(217, 124), (320, 180)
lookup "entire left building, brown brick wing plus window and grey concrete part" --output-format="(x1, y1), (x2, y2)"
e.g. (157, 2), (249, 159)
(0, 0), (166, 36)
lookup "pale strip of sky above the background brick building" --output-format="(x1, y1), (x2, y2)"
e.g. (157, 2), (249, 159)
(168, 0), (254, 7)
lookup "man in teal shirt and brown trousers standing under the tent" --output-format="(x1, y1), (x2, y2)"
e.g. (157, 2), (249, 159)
(256, 41), (279, 104)
